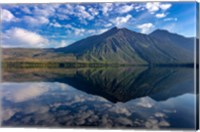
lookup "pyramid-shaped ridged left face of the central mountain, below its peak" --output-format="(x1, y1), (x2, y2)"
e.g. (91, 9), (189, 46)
(56, 27), (147, 64)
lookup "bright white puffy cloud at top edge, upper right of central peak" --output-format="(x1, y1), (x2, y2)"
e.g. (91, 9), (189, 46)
(145, 2), (171, 14)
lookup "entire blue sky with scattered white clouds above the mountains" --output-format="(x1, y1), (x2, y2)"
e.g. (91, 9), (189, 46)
(0, 2), (196, 48)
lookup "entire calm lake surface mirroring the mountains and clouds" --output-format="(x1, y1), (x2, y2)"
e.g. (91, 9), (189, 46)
(1, 67), (196, 129)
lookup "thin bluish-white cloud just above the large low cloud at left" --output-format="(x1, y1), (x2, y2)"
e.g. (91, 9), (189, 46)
(23, 16), (49, 26)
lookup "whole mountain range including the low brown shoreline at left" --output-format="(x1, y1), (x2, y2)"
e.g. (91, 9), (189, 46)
(3, 27), (194, 64)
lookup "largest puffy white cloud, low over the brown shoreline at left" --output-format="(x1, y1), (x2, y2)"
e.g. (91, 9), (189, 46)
(2, 27), (48, 48)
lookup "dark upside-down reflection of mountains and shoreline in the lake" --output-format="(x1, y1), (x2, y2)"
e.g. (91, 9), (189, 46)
(3, 67), (194, 103)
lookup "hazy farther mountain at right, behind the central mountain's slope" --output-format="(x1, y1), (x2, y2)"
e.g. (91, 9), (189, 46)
(149, 29), (195, 52)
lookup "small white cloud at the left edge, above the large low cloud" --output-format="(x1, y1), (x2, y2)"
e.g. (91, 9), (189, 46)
(2, 9), (17, 22)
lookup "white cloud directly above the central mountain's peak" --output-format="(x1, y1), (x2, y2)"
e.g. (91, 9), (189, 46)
(110, 14), (132, 26)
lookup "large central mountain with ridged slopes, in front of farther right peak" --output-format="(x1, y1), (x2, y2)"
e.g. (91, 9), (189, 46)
(56, 27), (193, 64)
